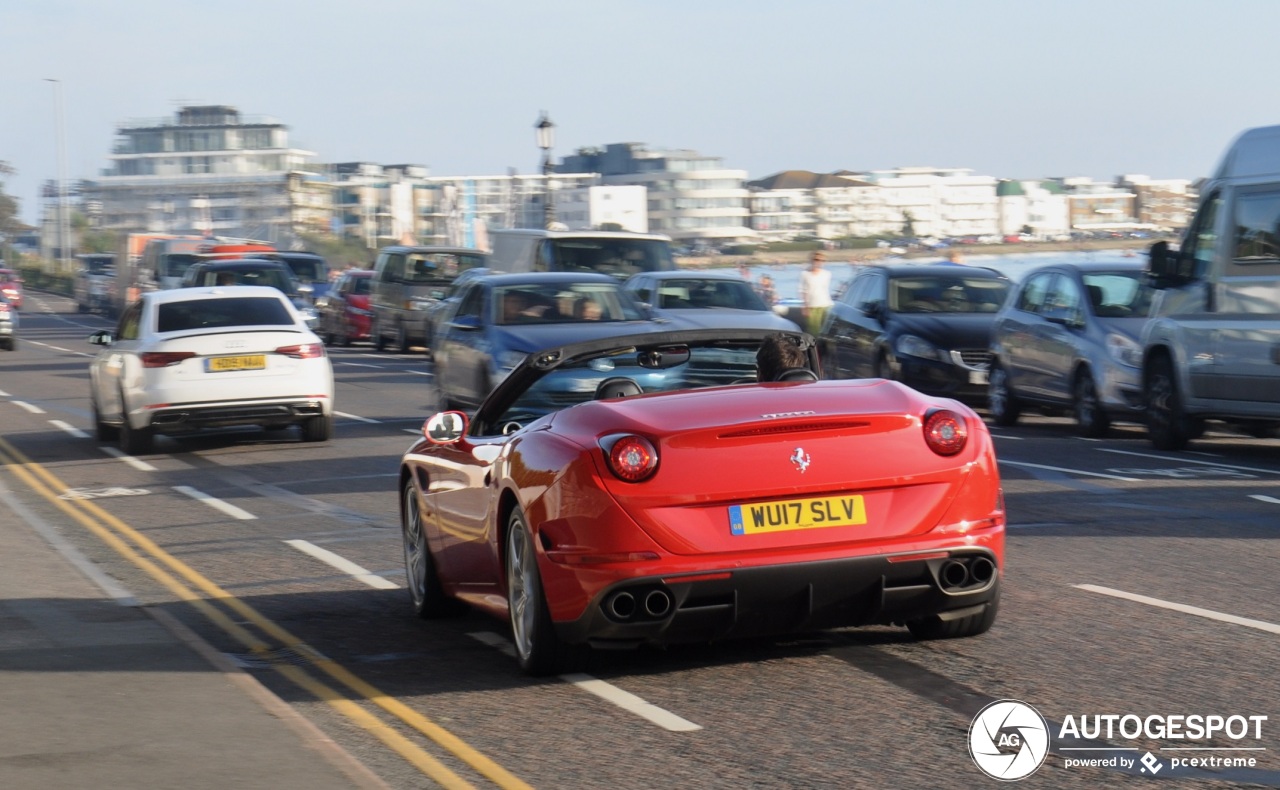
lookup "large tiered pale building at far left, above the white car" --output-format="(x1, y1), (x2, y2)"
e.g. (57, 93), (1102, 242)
(82, 105), (333, 243)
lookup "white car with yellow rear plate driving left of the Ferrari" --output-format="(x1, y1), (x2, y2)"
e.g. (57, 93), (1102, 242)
(88, 286), (333, 455)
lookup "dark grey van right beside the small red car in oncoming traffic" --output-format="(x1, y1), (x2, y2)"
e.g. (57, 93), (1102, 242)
(369, 246), (486, 353)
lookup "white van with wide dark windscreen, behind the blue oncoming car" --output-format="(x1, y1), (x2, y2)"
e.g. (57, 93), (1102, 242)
(489, 228), (676, 279)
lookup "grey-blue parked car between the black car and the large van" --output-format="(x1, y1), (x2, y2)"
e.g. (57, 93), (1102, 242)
(988, 261), (1155, 437)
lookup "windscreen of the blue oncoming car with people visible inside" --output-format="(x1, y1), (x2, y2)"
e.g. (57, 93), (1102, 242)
(493, 283), (646, 325)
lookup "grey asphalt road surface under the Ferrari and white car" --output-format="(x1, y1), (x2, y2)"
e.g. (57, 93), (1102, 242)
(0, 292), (1280, 790)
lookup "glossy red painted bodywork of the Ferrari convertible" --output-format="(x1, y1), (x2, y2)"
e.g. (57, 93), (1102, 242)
(404, 379), (1005, 640)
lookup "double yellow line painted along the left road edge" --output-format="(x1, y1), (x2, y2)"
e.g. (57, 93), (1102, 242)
(0, 438), (530, 790)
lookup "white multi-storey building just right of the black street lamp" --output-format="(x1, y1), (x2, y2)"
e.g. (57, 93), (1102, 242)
(557, 142), (755, 245)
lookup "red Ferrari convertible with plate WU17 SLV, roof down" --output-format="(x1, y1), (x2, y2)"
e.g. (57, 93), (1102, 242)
(399, 329), (1005, 675)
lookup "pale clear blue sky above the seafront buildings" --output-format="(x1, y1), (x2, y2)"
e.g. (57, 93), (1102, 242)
(0, 0), (1280, 223)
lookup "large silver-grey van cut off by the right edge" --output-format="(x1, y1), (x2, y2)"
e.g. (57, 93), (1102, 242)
(1143, 125), (1280, 449)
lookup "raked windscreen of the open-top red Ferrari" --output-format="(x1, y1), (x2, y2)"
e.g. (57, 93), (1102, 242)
(489, 342), (759, 433)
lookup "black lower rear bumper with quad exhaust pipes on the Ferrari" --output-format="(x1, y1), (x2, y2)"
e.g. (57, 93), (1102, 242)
(556, 548), (1000, 648)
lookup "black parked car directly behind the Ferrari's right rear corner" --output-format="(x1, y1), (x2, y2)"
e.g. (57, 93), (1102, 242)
(818, 264), (1010, 402)
